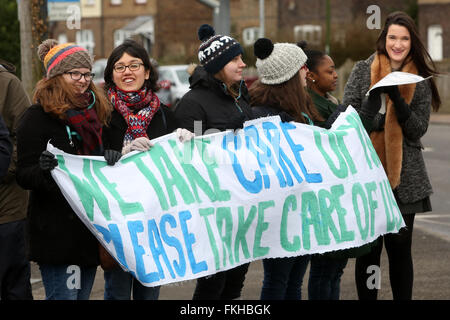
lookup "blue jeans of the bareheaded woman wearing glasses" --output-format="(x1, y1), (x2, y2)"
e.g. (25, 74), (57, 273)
(104, 268), (161, 300)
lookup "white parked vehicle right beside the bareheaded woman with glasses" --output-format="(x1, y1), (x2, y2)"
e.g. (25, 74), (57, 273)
(157, 64), (189, 108)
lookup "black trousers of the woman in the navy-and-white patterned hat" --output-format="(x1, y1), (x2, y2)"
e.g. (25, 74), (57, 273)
(192, 263), (250, 300)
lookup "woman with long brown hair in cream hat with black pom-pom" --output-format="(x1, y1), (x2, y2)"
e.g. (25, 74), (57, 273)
(250, 38), (323, 300)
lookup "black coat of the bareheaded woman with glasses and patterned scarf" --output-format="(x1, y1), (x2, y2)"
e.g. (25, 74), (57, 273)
(103, 104), (178, 151)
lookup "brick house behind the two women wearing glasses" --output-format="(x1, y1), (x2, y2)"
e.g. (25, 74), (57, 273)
(49, 0), (212, 59)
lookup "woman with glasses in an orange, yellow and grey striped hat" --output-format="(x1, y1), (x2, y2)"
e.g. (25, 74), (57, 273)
(17, 39), (117, 300)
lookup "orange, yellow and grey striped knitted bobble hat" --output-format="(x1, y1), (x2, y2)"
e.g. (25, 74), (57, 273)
(38, 39), (92, 79)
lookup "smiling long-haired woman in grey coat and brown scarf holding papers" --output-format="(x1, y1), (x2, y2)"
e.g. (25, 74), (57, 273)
(343, 12), (441, 299)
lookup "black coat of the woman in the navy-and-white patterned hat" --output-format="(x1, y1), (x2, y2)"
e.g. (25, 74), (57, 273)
(175, 67), (253, 135)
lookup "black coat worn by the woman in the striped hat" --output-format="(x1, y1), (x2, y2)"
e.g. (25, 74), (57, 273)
(17, 104), (99, 266)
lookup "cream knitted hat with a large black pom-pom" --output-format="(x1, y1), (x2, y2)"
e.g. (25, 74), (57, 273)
(253, 38), (308, 85)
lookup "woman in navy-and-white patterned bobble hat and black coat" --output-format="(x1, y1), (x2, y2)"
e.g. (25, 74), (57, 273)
(175, 24), (253, 300)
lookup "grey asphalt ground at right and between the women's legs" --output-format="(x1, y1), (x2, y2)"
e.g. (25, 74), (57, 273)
(32, 117), (450, 300)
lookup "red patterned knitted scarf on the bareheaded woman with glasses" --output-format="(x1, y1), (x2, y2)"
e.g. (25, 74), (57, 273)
(108, 87), (160, 147)
